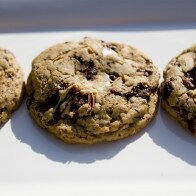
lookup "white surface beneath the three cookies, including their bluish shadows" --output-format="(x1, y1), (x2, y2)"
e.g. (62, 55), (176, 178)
(0, 29), (196, 195)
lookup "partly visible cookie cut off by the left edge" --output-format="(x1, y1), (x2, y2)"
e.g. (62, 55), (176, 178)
(0, 48), (25, 124)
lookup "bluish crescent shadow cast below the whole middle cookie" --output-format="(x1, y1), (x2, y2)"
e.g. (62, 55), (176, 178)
(11, 100), (146, 163)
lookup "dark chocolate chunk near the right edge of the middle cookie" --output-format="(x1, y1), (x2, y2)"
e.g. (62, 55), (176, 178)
(124, 83), (150, 101)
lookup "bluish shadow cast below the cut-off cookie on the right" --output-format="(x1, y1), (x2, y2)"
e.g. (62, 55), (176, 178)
(148, 107), (196, 165)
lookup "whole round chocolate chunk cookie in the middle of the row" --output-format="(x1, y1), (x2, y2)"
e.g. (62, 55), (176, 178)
(27, 37), (159, 144)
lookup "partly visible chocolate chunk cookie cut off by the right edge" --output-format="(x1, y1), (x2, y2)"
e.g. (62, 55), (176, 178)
(161, 45), (196, 135)
